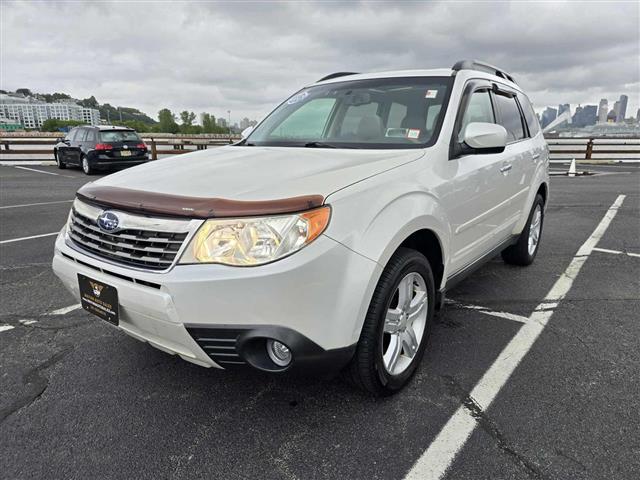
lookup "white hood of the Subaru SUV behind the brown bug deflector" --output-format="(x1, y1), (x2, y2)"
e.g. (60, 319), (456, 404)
(93, 146), (424, 201)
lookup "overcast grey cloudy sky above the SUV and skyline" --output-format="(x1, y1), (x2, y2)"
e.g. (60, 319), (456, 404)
(0, 0), (640, 121)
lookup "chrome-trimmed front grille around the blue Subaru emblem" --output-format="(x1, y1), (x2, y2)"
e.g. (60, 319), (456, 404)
(67, 200), (198, 271)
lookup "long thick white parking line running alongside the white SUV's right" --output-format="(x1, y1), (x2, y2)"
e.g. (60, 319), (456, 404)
(405, 195), (625, 480)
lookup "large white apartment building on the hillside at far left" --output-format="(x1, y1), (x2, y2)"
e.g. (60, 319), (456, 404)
(0, 96), (100, 128)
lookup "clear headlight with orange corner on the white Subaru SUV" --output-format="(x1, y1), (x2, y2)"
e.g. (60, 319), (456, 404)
(179, 206), (331, 266)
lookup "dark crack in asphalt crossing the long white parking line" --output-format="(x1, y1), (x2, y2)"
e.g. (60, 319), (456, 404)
(441, 375), (547, 479)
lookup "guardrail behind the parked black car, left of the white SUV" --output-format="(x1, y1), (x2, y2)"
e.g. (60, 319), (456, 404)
(0, 135), (240, 160)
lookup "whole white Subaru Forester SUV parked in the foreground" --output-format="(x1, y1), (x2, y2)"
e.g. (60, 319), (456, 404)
(53, 61), (549, 395)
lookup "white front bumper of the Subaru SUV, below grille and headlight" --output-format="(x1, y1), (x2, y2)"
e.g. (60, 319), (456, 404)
(53, 229), (381, 371)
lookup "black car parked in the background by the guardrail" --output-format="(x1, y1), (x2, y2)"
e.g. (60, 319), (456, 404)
(53, 125), (149, 175)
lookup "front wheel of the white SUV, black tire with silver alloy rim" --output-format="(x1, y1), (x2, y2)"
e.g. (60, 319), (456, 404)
(344, 248), (435, 397)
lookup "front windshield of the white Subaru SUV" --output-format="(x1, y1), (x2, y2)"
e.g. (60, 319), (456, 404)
(248, 77), (452, 148)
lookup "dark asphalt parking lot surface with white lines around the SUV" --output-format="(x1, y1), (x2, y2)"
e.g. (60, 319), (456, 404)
(0, 160), (640, 480)
